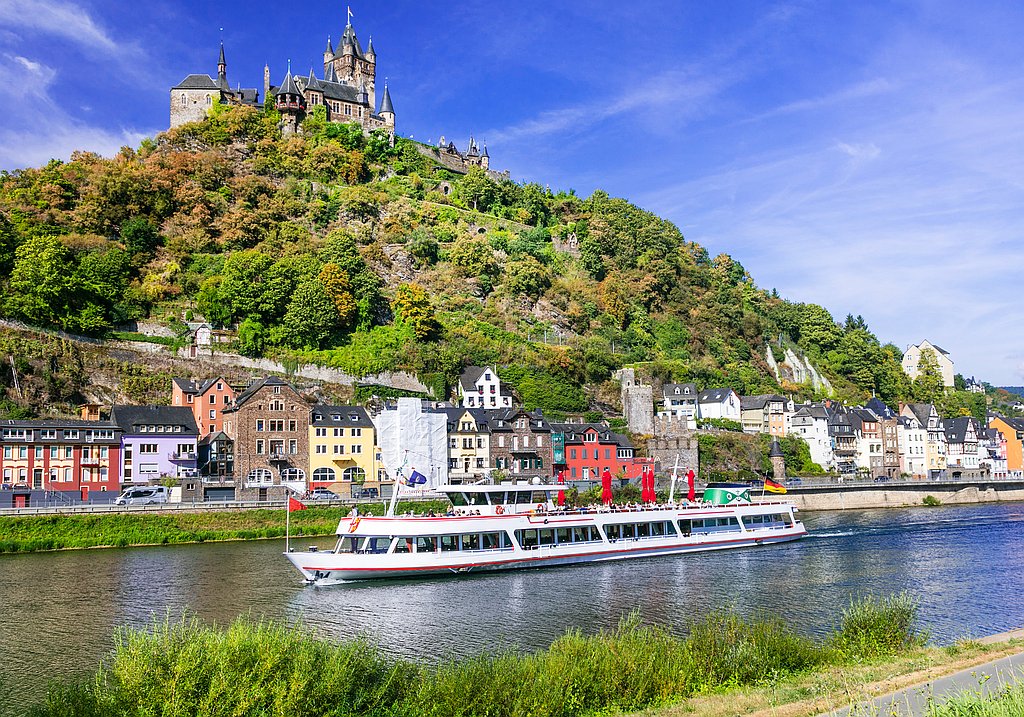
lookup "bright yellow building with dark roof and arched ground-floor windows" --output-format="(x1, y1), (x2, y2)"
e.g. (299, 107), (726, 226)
(308, 406), (382, 498)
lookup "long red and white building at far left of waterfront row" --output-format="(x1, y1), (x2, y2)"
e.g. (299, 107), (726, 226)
(0, 419), (121, 507)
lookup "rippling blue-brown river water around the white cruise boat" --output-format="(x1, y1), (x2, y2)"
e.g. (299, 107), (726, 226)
(0, 504), (1024, 712)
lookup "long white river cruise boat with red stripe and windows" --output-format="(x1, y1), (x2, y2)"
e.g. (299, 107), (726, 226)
(285, 483), (807, 583)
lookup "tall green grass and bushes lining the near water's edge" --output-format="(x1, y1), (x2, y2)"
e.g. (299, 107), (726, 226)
(33, 598), (933, 717)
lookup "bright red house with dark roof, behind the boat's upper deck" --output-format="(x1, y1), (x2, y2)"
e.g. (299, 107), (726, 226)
(551, 423), (645, 480)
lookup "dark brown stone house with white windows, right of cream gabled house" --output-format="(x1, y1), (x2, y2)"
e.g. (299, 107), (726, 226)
(487, 408), (554, 479)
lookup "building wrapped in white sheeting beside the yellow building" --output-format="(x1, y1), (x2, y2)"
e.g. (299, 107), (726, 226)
(372, 398), (449, 489)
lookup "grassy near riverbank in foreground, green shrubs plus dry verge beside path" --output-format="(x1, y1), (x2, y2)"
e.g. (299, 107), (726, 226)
(14, 595), (1020, 717)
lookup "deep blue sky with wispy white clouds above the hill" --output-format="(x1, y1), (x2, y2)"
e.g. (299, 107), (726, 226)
(0, 0), (1024, 385)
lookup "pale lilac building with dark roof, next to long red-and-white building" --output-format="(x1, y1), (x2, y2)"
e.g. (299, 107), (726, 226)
(111, 406), (199, 491)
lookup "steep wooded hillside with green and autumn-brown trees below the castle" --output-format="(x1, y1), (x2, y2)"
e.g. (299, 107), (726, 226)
(0, 100), (987, 412)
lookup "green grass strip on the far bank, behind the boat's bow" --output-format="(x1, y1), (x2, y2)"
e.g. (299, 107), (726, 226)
(0, 502), (443, 553)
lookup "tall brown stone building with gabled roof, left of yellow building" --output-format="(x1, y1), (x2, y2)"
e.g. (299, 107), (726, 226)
(224, 376), (309, 500)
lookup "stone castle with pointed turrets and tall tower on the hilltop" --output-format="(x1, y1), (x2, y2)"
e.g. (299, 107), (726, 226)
(170, 11), (394, 136)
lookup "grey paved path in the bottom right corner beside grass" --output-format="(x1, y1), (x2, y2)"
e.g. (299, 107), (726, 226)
(824, 628), (1024, 717)
